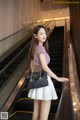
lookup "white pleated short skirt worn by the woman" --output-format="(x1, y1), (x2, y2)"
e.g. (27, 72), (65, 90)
(28, 75), (58, 100)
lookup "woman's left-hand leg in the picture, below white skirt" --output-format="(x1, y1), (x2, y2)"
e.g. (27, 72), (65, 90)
(32, 100), (40, 120)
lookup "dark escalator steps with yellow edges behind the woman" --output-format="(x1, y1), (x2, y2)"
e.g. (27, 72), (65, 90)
(9, 27), (64, 120)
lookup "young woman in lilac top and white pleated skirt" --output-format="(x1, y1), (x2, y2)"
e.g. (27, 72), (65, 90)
(28, 25), (69, 120)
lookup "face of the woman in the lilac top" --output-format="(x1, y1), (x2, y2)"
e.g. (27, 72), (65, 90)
(35, 28), (47, 45)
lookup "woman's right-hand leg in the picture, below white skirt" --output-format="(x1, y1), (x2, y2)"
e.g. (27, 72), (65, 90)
(39, 100), (51, 120)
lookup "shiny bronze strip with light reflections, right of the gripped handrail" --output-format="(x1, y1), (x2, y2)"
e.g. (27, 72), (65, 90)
(68, 27), (80, 120)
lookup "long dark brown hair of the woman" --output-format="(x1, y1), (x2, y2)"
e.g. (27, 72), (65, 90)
(29, 25), (49, 60)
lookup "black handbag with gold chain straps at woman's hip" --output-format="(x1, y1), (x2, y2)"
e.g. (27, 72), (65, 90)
(26, 71), (48, 90)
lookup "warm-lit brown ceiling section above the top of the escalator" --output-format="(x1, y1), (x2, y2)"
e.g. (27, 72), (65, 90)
(41, 0), (69, 25)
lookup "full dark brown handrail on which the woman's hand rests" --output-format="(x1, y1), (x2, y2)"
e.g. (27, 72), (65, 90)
(55, 20), (76, 120)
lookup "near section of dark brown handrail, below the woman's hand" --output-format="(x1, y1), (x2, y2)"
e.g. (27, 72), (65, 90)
(55, 82), (75, 120)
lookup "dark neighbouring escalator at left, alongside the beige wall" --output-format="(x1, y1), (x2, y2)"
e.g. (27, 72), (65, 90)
(0, 37), (31, 89)
